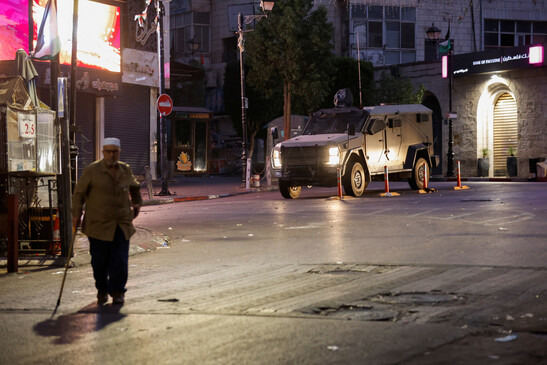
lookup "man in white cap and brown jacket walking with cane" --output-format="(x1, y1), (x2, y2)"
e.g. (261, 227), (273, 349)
(72, 138), (142, 305)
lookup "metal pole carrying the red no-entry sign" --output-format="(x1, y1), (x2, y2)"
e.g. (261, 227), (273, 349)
(156, 0), (171, 196)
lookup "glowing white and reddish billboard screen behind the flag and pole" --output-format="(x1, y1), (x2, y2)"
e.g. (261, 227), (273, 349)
(32, 0), (120, 72)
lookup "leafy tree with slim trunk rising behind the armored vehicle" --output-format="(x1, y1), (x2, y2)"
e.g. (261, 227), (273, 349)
(245, 0), (335, 138)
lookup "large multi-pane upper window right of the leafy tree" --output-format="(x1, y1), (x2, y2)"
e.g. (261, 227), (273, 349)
(349, 5), (416, 65)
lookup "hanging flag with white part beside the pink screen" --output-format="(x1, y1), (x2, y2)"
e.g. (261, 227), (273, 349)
(33, 0), (61, 60)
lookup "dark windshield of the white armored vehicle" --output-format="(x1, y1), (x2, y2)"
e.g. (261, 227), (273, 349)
(302, 113), (365, 135)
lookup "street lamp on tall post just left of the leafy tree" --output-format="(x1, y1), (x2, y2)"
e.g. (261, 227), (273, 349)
(236, 0), (275, 189)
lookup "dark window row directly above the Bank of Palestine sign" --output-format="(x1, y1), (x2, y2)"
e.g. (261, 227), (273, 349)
(484, 19), (547, 48)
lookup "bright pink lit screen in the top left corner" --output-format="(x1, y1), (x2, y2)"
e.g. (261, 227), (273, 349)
(0, 0), (29, 61)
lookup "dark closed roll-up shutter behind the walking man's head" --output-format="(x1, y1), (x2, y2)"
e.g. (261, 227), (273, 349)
(104, 84), (150, 175)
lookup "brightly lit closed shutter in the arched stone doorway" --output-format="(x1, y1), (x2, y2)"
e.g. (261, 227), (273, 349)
(493, 93), (518, 176)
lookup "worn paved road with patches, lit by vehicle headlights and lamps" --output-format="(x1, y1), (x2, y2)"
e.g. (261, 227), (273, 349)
(0, 183), (547, 364)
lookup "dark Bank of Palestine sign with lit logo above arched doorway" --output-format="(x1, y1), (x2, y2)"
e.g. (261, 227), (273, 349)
(452, 45), (545, 77)
